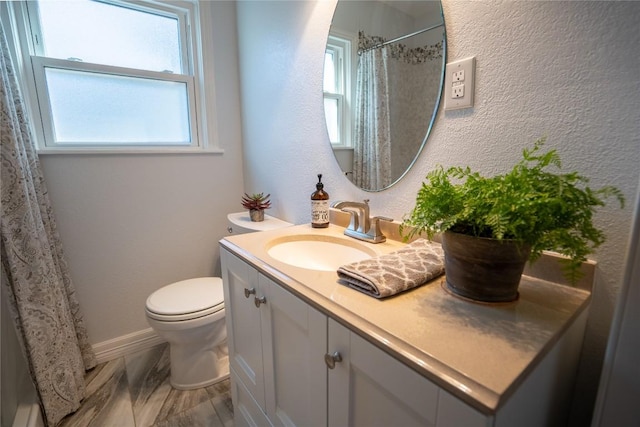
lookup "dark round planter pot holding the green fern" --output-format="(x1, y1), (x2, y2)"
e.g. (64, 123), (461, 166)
(442, 231), (531, 302)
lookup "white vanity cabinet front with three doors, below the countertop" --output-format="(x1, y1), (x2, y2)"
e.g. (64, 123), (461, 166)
(221, 249), (482, 427)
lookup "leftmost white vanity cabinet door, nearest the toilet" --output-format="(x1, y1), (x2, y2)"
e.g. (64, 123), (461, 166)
(220, 248), (265, 411)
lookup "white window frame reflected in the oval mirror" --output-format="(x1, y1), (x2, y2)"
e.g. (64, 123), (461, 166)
(323, 29), (357, 148)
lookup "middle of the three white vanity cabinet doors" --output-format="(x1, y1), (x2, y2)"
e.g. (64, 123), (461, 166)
(259, 275), (327, 427)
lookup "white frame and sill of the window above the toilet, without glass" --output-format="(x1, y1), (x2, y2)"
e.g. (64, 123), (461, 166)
(3, 0), (223, 154)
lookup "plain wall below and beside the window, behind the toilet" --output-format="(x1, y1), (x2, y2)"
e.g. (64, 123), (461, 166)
(40, 2), (243, 344)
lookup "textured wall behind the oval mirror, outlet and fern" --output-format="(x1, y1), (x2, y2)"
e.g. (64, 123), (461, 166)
(238, 0), (640, 425)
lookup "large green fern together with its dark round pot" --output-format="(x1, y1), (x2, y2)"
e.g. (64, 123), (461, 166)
(401, 138), (624, 302)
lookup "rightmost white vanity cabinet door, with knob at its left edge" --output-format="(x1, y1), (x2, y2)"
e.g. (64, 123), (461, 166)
(328, 319), (438, 427)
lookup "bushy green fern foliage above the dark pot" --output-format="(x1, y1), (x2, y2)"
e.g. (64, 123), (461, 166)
(401, 138), (624, 281)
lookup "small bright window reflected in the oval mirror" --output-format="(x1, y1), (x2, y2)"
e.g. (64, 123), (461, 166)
(323, 34), (352, 147)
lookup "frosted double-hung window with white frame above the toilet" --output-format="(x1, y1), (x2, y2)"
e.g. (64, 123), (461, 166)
(8, 0), (218, 152)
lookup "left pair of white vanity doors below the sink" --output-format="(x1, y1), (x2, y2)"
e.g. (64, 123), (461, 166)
(221, 250), (327, 426)
